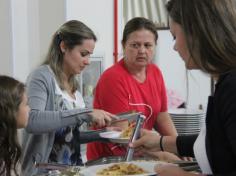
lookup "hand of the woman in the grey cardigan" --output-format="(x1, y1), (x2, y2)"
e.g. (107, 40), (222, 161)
(89, 109), (115, 127)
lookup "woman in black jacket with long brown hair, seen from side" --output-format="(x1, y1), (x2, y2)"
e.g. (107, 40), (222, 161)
(131, 0), (236, 176)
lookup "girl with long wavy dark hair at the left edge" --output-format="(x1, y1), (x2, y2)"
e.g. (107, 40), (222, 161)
(0, 75), (29, 176)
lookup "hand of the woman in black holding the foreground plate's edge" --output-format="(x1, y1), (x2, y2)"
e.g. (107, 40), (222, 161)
(154, 164), (196, 176)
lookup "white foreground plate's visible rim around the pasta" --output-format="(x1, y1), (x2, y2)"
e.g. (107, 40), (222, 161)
(80, 161), (169, 176)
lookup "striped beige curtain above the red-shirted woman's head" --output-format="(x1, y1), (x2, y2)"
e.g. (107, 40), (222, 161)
(123, 0), (168, 28)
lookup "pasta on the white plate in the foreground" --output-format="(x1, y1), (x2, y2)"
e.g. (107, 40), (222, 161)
(96, 163), (147, 176)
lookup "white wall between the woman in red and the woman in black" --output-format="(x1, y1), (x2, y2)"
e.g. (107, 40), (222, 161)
(155, 30), (210, 108)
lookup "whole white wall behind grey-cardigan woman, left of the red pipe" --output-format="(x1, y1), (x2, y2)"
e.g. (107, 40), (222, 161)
(0, 0), (122, 77)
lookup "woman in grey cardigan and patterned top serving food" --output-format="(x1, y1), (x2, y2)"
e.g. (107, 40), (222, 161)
(22, 20), (113, 176)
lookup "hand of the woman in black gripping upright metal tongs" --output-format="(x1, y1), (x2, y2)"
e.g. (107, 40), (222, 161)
(129, 129), (160, 152)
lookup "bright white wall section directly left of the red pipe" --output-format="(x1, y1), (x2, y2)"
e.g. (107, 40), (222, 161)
(66, 0), (114, 68)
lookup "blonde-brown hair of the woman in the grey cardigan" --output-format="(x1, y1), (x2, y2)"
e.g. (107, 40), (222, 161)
(43, 20), (97, 92)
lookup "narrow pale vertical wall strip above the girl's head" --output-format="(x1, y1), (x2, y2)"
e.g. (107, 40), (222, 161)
(11, 0), (29, 81)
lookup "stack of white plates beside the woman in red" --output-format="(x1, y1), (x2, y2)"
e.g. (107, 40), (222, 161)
(169, 108), (206, 135)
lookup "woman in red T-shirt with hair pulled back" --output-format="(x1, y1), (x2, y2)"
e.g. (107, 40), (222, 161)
(87, 17), (179, 160)
